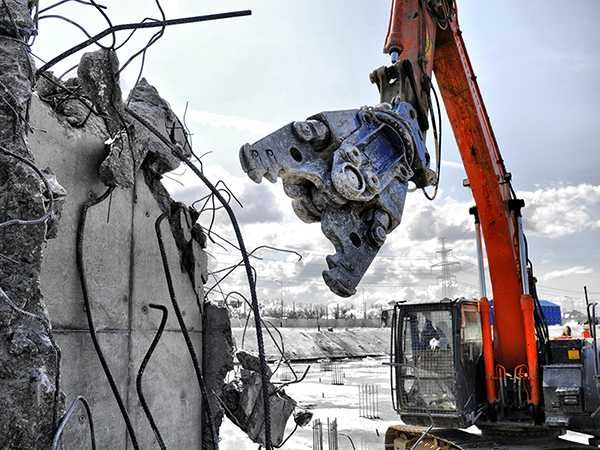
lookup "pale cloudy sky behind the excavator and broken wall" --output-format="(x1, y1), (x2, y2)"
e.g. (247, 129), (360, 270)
(34, 0), (600, 308)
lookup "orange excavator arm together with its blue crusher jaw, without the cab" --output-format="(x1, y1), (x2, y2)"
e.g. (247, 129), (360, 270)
(240, 0), (540, 414)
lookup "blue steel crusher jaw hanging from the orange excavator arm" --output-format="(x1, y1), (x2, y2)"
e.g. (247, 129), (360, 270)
(240, 101), (436, 297)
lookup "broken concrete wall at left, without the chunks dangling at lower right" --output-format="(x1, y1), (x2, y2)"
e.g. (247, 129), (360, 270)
(0, 6), (223, 440)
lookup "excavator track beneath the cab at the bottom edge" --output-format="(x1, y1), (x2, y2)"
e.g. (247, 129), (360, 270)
(385, 425), (598, 450)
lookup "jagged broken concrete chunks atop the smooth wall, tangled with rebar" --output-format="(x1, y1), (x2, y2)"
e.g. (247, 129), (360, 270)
(36, 55), (192, 188)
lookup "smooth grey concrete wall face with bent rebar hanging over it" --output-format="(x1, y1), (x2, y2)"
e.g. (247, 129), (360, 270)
(31, 81), (211, 448)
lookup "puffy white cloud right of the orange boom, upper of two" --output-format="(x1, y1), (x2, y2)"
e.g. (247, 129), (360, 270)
(520, 184), (600, 239)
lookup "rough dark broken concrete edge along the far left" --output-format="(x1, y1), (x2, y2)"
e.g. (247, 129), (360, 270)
(0, 0), (62, 449)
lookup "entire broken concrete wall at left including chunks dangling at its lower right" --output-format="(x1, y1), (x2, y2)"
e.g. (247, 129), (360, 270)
(0, 0), (310, 449)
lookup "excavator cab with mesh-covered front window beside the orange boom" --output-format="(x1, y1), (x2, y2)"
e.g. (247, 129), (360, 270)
(390, 299), (485, 428)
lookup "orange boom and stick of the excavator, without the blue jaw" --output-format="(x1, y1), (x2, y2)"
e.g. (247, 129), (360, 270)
(382, 0), (540, 406)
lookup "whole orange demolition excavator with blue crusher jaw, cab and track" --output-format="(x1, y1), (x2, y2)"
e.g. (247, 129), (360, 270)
(240, 0), (600, 442)
